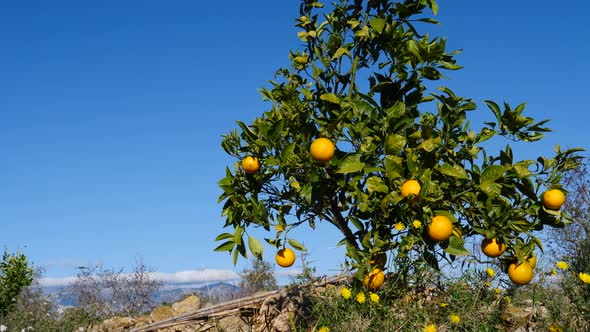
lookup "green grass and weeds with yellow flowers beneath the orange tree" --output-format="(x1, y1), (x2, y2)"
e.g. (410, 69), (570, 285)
(298, 271), (590, 332)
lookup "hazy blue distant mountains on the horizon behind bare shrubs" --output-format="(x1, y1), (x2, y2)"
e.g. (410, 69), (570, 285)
(43, 282), (240, 307)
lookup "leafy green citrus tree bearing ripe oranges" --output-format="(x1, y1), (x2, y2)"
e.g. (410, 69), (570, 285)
(216, 0), (580, 286)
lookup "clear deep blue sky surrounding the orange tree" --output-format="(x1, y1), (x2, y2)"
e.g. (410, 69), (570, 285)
(0, 0), (590, 286)
